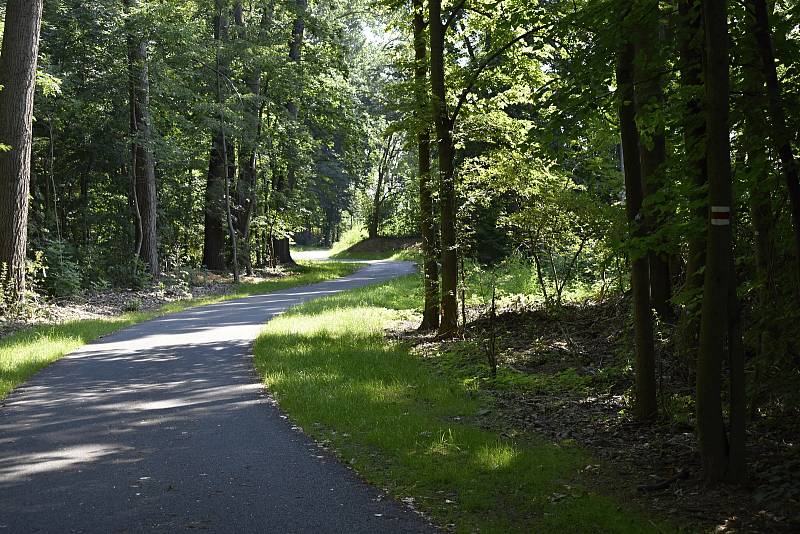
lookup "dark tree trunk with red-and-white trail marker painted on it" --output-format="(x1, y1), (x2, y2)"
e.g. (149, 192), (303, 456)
(696, 0), (743, 482)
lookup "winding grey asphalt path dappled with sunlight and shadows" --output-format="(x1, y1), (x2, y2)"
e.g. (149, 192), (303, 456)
(0, 262), (433, 534)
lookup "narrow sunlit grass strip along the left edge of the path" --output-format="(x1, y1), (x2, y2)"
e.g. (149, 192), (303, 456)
(0, 263), (359, 399)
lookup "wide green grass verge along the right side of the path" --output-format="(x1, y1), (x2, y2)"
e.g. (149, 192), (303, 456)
(255, 276), (671, 533)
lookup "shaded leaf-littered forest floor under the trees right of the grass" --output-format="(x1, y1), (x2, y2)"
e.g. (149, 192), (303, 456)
(389, 298), (800, 533)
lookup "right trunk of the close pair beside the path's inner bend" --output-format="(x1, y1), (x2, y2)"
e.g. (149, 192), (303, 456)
(428, 0), (458, 336)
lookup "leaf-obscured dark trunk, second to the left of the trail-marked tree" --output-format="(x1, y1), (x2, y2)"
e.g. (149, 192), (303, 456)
(633, 0), (672, 317)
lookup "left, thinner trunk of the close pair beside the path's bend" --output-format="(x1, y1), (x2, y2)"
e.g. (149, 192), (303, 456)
(413, 0), (439, 330)
